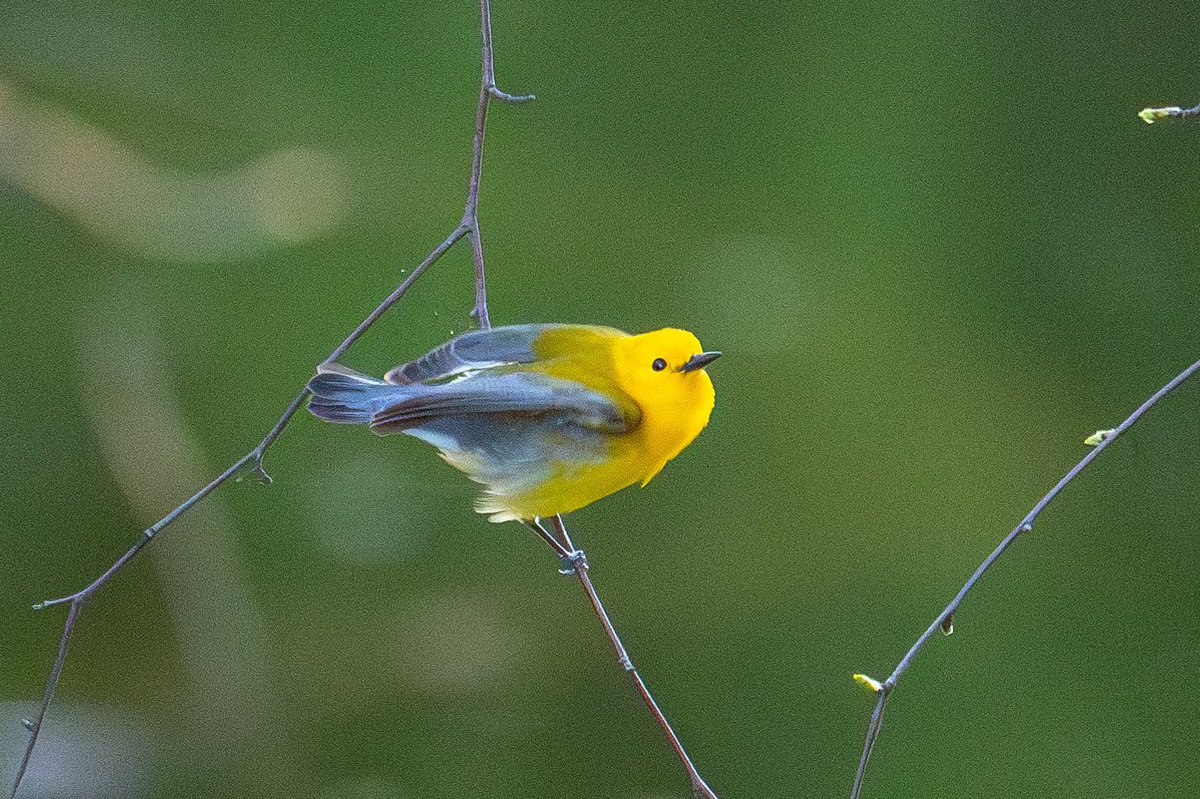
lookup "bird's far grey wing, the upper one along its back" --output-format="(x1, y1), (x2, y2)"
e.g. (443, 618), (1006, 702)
(384, 325), (560, 385)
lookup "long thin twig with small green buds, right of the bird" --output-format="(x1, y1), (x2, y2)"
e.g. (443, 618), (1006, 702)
(850, 361), (1200, 799)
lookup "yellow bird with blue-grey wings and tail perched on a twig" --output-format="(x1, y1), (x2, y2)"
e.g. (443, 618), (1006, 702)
(308, 324), (720, 522)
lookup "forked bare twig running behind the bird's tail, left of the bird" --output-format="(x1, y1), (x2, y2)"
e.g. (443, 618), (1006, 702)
(10, 0), (533, 799)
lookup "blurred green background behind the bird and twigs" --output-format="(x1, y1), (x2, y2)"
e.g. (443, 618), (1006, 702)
(0, 0), (1200, 799)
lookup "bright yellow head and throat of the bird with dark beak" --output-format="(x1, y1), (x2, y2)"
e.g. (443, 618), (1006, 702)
(614, 328), (720, 471)
